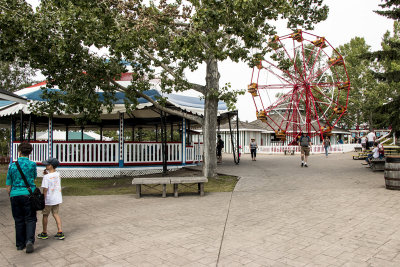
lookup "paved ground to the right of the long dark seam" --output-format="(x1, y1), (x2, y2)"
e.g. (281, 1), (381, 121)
(218, 154), (400, 266)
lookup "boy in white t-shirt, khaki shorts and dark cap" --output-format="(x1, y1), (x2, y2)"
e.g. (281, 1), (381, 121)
(37, 158), (65, 240)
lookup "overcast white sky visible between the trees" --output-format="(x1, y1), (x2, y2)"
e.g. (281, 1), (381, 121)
(27, 0), (393, 121)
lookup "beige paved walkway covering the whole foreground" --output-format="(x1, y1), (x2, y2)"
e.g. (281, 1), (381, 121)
(0, 154), (400, 267)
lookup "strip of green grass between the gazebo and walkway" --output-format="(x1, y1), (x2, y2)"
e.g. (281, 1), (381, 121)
(0, 168), (238, 196)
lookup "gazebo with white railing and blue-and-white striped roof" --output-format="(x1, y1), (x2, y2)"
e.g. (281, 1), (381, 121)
(0, 73), (237, 177)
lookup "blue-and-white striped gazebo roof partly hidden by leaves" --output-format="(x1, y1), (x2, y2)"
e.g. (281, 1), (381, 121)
(0, 73), (229, 117)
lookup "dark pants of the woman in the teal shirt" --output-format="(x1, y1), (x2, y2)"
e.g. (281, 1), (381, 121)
(11, 195), (37, 247)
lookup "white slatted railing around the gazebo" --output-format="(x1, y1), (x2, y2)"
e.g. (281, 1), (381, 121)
(12, 141), (202, 166)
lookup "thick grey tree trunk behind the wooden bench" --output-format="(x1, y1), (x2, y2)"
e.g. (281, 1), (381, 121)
(203, 59), (220, 180)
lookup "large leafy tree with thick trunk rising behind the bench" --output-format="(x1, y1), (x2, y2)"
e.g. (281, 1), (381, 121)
(14, 0), (328, 177)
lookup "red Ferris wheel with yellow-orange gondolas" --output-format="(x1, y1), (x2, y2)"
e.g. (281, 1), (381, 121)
(248, 30), (350, 145)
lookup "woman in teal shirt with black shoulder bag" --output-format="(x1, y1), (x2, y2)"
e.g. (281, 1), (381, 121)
(6, 142), (37, 253)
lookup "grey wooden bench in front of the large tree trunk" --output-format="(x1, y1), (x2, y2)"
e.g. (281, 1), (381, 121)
(132, 176), (208, 198)
